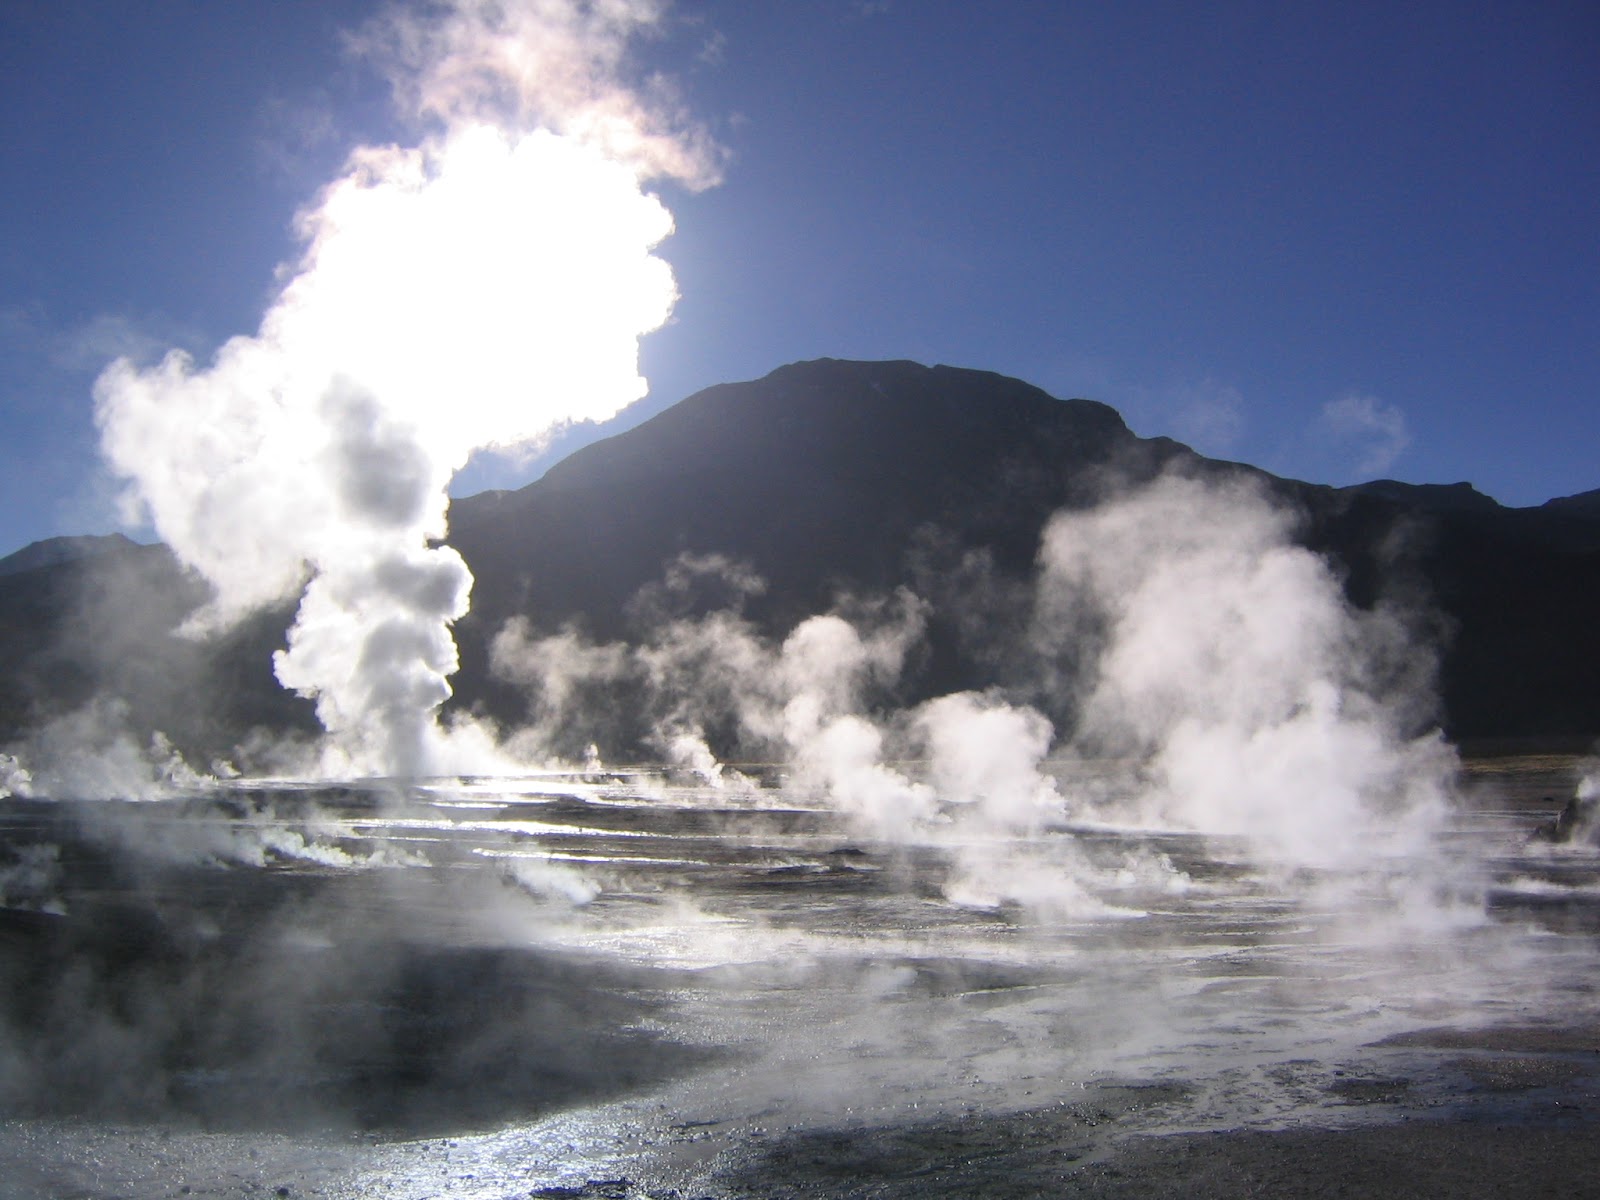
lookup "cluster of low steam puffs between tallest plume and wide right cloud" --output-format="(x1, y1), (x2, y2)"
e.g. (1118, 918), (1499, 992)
(493, 560), (1104, 914)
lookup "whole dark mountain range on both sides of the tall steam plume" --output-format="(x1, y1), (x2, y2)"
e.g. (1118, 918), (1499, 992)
(0, 360), (1600, 771)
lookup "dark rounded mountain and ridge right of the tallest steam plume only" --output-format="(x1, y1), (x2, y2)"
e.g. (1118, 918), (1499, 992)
(451, 360), (1600, 738)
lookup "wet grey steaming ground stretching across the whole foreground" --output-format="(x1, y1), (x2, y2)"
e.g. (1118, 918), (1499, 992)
(0, 757), (1600, 1197)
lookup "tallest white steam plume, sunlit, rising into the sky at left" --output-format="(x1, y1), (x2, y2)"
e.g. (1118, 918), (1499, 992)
(94, 0), (715, 774)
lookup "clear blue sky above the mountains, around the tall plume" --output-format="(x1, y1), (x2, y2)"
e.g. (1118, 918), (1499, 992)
(0, 0), (1600, 554)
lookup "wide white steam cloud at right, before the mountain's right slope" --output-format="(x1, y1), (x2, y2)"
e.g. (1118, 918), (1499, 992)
(1035, 477), (1456, 866)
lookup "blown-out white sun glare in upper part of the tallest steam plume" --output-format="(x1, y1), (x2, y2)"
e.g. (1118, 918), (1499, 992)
(288, 125), (677, 454)
